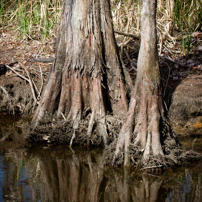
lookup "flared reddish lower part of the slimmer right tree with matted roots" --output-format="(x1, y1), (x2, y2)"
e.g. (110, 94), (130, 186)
(106, 79), (201, 168)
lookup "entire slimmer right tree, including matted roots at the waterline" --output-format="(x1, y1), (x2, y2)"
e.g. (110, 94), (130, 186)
(105, 0), (200, 168)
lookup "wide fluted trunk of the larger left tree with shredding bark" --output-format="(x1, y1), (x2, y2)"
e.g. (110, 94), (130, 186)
(32, 0), (128, 144)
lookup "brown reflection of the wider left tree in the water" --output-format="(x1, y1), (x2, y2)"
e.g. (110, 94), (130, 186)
(33, 148), (104, 202)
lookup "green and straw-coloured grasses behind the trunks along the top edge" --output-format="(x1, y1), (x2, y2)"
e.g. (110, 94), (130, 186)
(0, 0), (202, 51)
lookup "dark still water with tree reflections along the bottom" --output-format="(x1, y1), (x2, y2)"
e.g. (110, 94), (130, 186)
(0, 114), (202, 202)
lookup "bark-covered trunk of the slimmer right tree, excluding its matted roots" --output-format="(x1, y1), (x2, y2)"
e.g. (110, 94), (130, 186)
(114, 0), (164, 165)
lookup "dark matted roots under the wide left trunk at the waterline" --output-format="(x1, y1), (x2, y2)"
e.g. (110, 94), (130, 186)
(28, 114), (122, 147)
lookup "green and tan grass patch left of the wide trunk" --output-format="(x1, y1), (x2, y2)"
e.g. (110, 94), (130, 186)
(0, 0), (61, 40)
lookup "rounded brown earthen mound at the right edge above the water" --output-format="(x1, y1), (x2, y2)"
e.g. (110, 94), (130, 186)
(169, 75), (202, 135)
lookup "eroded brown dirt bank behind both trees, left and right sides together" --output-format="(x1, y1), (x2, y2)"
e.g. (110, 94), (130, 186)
(0, 32), (202, 136)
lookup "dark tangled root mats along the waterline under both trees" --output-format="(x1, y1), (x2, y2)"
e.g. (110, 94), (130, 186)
(29, 113), (201, 171)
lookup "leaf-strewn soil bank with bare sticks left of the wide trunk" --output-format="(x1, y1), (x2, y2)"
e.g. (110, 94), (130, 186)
(0, 30), (54, 115)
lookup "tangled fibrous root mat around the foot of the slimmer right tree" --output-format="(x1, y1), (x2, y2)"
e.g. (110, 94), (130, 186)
(105, 123), (201, 170)
